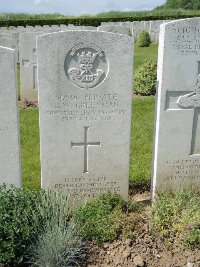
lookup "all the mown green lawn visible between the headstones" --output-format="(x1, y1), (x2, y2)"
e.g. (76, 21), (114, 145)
(18, 44), (157, 188)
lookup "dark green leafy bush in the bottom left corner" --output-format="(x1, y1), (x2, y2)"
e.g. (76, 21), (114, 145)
(0, 185), (43, 266)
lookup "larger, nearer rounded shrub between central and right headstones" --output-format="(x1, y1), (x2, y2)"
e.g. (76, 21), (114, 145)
(134, 60), (157, 96)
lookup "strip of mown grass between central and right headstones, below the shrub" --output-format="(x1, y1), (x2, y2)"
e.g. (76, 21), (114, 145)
(130, 97), (155, 185)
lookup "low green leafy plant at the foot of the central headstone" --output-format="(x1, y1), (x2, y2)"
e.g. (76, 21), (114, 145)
(73, 194), (139, 244)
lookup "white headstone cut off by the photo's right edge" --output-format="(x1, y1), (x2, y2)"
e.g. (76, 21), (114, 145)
(152, 18), (200, 196)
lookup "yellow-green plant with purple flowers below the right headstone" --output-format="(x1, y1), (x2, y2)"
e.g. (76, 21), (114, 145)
(151, 189), (200, 249)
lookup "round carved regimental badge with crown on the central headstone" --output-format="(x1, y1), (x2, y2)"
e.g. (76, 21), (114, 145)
(65, 44), (108, 88)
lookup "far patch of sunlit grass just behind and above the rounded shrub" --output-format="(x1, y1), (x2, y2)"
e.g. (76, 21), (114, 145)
(134, 43), (158, 71)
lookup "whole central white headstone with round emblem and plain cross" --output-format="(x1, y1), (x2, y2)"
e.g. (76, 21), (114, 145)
(37, 31), (133, 198)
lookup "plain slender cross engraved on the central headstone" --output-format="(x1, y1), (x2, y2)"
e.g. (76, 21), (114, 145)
(71, 126), (101, 173)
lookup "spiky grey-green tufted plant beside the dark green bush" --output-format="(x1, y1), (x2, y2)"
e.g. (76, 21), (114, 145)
(29, 192), (86, 267)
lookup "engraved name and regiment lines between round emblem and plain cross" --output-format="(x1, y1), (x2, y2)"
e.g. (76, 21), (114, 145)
(47, 93), (125, 122)
